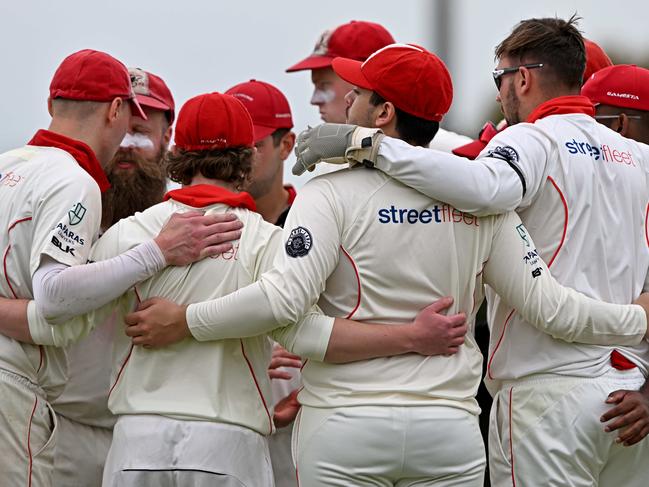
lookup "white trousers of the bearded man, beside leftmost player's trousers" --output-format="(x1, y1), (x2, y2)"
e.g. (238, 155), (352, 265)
(53, 413), (113, 487)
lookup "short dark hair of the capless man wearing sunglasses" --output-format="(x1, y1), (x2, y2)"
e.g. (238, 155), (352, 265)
(496, 15), (586, 91)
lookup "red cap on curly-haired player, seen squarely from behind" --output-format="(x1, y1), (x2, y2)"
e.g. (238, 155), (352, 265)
(175, 93), (254, 151)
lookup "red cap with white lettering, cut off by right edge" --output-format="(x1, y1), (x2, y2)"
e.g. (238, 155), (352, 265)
(581, 64), (649, 111)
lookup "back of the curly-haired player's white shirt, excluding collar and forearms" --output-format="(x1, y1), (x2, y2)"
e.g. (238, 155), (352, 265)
(93, 193), (280, 434)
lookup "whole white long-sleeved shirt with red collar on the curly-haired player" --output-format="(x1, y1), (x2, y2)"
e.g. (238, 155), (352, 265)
(30, 185), (333, 435)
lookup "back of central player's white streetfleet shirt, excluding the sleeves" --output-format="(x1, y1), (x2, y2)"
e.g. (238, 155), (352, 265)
(285, 167), (501, 412)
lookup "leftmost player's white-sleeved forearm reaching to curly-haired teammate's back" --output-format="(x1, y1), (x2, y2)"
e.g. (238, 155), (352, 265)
(33, 241), (166, 324)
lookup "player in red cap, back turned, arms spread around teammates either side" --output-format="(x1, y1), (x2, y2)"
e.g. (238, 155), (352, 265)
(127, 44), (646, 487)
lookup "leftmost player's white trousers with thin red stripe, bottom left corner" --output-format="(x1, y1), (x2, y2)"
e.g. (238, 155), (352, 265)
(0, 369), (57, 487)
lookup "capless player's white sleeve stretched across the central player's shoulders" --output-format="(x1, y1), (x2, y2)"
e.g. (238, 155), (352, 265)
(375, 137), (523, 216)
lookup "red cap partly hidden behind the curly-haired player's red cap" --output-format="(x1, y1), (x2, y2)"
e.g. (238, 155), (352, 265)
(225, 79), (293, 142)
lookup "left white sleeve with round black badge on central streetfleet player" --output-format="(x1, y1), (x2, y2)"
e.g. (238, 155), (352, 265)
(187, 180), (341, 346)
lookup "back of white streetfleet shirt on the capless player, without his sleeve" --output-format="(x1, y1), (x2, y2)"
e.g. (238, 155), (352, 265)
(487, 114), (649, 386)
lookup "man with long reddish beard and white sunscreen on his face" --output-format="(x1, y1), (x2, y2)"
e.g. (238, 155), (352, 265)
(52, 68), (175, 487)
